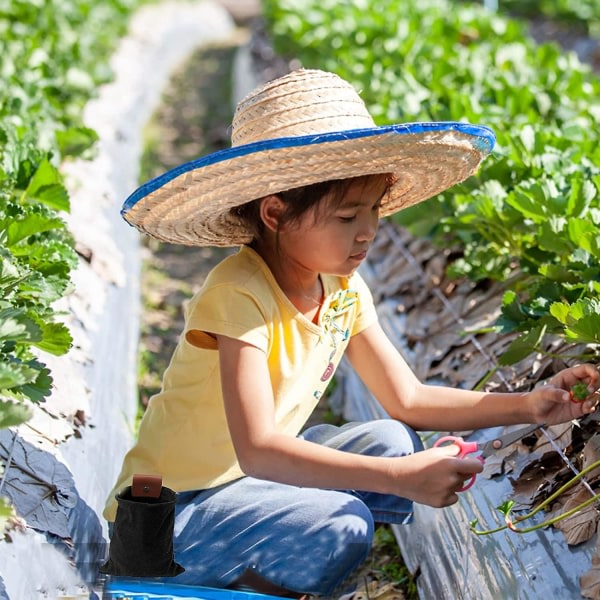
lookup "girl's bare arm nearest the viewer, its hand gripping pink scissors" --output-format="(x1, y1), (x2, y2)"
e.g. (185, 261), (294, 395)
(217, 336), (482, 506)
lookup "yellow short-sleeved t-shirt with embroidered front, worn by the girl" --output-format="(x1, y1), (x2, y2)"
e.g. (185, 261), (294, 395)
(104, 246), (377, 521)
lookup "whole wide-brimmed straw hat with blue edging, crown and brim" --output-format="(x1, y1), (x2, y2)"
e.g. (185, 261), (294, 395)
(121, 69), (495, 246)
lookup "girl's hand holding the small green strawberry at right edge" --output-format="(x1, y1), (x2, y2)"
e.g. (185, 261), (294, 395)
(528, 364), (600, 425)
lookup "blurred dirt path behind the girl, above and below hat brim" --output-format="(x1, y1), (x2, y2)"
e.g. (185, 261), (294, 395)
(140, 30), (239, 404)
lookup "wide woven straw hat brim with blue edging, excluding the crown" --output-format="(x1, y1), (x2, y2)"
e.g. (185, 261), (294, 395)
(121, 122), (495, 246)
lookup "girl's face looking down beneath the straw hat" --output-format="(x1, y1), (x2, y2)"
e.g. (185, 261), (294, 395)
(279, 177), (388, 276)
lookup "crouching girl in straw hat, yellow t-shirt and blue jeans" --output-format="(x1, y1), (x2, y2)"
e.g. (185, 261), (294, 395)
(105, 70), (599, 597)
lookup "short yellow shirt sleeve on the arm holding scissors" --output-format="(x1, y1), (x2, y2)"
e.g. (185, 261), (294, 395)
(185, 285), (269, 352)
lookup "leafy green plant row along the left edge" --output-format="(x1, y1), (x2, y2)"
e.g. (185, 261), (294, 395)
(0, 0), (144, 532)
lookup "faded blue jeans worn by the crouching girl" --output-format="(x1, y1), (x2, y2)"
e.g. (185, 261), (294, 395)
(113, 419), (423, 595)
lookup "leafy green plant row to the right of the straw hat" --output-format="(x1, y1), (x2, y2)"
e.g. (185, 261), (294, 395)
(264, 0), (600, 372)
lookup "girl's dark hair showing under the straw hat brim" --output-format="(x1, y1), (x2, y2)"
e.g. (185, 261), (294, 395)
(232, 173), (395, 240)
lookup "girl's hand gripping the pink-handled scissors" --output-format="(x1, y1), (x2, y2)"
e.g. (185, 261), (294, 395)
(394, 444), (483, 508)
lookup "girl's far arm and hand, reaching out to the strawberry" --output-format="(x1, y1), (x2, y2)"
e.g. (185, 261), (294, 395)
(346, 323), (600, 431)
